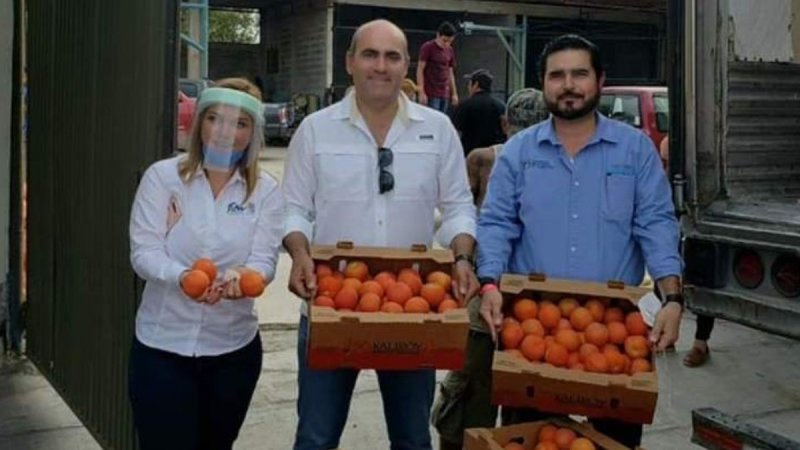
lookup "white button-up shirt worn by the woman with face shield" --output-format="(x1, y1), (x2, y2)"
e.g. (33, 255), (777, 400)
(130, 155), (285, 356)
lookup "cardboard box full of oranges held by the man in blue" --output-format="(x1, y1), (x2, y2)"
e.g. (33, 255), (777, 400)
(492, 275), (658, 423)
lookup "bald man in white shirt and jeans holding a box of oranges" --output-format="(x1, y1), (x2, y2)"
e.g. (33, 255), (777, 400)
(283, 20), (477, 450)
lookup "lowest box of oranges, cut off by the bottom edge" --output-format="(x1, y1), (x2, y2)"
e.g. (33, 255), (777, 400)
(464, 419), (631, 450)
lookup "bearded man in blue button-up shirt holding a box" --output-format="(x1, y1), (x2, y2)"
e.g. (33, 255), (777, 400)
(477, 35), (683, 447)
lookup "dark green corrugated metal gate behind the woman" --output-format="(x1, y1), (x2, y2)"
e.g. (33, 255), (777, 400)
(27, 0), (177, 449)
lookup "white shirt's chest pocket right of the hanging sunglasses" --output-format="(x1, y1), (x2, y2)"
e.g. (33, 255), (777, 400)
(389, 144), (439, 200)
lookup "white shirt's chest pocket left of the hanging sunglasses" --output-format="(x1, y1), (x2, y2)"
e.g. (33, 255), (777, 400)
(316, 147), (378, 201)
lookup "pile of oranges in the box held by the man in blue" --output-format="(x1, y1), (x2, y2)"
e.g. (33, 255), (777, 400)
(500, 297), (652, 375)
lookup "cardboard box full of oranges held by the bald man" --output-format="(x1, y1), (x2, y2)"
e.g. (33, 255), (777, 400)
(308, 243), (469, 370)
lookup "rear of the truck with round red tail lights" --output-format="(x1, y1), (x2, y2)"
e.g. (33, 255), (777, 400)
(669, 0), (800, 339)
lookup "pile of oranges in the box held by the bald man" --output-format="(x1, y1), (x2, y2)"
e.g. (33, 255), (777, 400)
(314, 261), (458, 313)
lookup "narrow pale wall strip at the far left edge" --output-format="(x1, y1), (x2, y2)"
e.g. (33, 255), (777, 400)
(0, 0), (14, 290)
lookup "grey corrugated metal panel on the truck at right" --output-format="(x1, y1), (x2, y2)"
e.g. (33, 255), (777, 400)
(725, 62), (800, 197)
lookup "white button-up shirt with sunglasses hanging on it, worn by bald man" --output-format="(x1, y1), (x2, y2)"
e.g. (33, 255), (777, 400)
(283, 93), (475, 258)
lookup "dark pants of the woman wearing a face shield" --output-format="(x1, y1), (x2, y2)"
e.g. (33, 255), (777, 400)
(128, 333), (262, 450)
